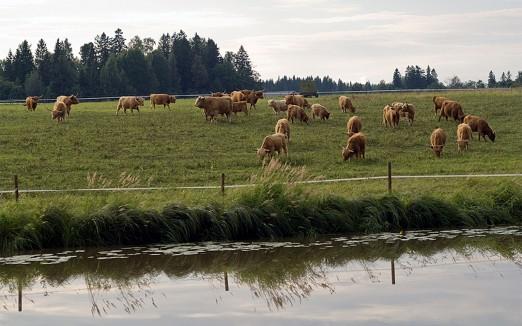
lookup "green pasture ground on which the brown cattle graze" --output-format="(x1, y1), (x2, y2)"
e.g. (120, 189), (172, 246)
(0, 90), (522, 208)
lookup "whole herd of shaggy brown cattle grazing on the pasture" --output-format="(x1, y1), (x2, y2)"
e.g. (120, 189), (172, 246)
(24, 90), (496, 161)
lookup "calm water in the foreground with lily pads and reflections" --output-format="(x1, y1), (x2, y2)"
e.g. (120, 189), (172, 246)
(0, 227), (522, 326)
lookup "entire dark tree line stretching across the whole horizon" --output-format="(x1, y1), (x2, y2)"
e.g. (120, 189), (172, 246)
(0, 29), (522, 99)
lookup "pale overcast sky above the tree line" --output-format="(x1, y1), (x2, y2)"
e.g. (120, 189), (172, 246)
(0, 0), (522, 82)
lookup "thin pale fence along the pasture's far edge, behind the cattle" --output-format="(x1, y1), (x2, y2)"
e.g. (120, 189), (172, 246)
(0, 88), (513, 104)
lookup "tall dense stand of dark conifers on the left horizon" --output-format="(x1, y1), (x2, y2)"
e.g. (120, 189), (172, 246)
(0, 29), (260, 99)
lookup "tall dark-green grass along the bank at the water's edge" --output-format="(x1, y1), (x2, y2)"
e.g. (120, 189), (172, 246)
(0, 161), (522, 252)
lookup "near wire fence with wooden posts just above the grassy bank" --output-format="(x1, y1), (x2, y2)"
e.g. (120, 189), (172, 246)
(0, 171), (522, 195)
